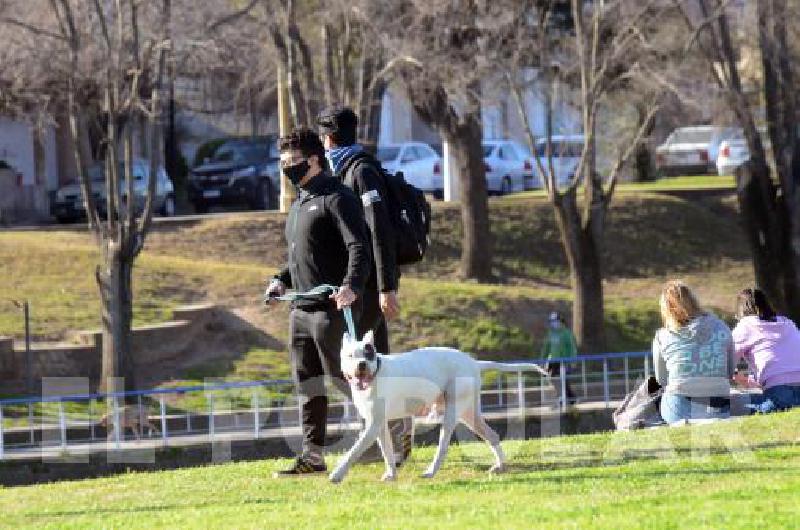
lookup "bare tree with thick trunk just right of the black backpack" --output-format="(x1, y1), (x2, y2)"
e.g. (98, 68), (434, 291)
(359, 0), (497, 281)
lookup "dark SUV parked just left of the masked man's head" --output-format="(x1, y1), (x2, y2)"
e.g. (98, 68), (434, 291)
(189, 137), (280, 213)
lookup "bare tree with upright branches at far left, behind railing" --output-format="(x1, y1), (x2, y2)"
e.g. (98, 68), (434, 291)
(3, 0), (171, 390)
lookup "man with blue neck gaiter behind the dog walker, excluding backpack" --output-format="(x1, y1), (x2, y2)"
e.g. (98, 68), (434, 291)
(317, 106), (411, 462)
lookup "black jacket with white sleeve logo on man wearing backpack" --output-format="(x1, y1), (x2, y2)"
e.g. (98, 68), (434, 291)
(336, 153), (400, 292)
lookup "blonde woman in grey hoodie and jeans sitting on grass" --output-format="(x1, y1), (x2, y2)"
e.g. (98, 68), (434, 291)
(653, 280), (735, 423)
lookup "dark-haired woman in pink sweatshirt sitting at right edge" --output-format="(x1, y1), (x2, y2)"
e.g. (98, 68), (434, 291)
(733, 289), (800, 413)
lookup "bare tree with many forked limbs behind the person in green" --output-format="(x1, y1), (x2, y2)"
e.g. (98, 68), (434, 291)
(506, 0), (662, 352)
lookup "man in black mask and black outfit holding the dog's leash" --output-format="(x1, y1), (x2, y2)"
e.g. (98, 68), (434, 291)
(266, 129), (370, 476)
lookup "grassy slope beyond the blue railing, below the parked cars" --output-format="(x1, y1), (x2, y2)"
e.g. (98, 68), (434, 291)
(0, 185), (752, 379)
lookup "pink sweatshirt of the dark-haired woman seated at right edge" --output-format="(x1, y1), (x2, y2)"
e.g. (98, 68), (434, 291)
(733, 316), (800, 388)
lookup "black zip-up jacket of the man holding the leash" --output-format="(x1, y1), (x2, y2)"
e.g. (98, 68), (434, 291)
(275, 172), (370, 308)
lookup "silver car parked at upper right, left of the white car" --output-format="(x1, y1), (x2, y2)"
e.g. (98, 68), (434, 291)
(656, 126), (742, 175)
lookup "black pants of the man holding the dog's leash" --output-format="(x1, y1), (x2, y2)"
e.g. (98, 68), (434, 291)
(289, 307), (358, 455)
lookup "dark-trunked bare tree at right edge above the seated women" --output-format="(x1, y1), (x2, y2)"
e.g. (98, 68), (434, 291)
(674, 0), (800, 321)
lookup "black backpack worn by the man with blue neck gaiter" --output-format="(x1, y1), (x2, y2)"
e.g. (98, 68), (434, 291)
(345, 153), (431, 265)
